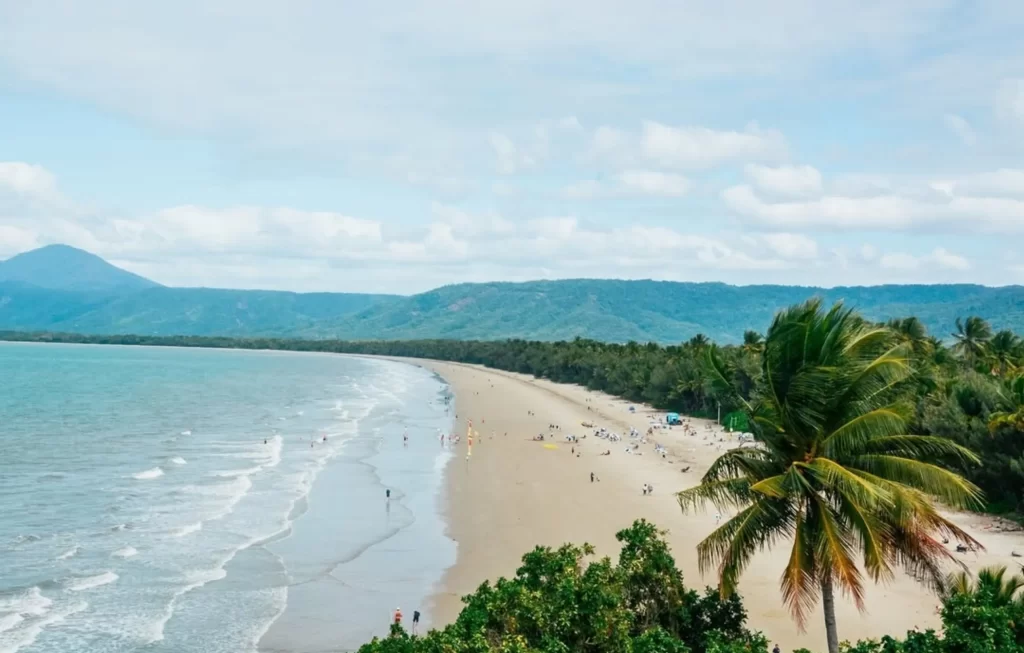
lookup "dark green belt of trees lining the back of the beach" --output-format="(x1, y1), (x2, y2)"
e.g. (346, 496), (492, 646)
(0, 307), (1024, 514)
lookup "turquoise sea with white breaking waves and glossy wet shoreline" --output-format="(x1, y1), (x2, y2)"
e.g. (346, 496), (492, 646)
(0, 343), (456, 653)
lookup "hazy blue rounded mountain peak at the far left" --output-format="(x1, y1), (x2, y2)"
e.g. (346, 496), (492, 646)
(0, 245), (160, 292)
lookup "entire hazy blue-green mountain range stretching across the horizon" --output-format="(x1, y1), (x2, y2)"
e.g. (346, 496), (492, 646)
(0, 246), (1024, 343)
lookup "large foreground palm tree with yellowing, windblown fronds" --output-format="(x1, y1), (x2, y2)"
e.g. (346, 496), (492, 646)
(678, 300), (981, 653)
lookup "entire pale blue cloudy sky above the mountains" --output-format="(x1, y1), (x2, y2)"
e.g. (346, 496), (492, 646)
(0, 0), (1024, 294)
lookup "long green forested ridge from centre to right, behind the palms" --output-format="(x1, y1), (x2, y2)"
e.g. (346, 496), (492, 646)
(309, 279), (1024, 343)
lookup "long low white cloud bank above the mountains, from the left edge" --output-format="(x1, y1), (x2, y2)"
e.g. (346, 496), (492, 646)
(0, 162), (808, 292)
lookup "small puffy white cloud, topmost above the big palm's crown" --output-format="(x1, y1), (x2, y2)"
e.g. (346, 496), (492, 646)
(640, 121), (786, 169)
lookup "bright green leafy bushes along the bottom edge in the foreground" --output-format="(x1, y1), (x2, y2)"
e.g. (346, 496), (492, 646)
(359, 520), (1024, 653)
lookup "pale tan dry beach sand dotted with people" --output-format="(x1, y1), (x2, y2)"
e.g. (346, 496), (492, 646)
(408, 361), (1024, 651)
